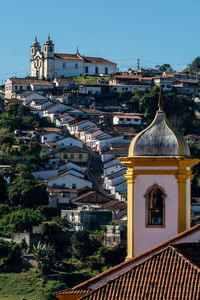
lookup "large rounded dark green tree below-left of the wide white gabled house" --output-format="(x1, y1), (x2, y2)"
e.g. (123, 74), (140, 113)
(9, 179), (48, 208)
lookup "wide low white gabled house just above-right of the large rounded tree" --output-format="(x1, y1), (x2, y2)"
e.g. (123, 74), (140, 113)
(45, 173), (92, 189)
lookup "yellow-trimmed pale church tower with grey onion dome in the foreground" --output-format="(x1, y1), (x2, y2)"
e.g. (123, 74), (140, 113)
(120, 92), (200, 259)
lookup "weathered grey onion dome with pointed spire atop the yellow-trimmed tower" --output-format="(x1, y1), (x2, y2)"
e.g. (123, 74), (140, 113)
(129, 91), (190, 157)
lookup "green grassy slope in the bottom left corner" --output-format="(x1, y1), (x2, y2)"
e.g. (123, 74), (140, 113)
(0, 269), (48, 300)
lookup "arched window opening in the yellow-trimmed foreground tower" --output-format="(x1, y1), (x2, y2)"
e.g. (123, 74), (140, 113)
(144, 184), (166, 227)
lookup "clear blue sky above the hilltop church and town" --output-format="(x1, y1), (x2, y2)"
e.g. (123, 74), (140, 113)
(0, 0), (200, 84)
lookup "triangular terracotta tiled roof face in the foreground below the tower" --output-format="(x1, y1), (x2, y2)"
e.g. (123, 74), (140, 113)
(80, 246), (200, 300)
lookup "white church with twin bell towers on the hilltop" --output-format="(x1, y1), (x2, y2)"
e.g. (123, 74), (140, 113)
(31, 36), (117, 79)
